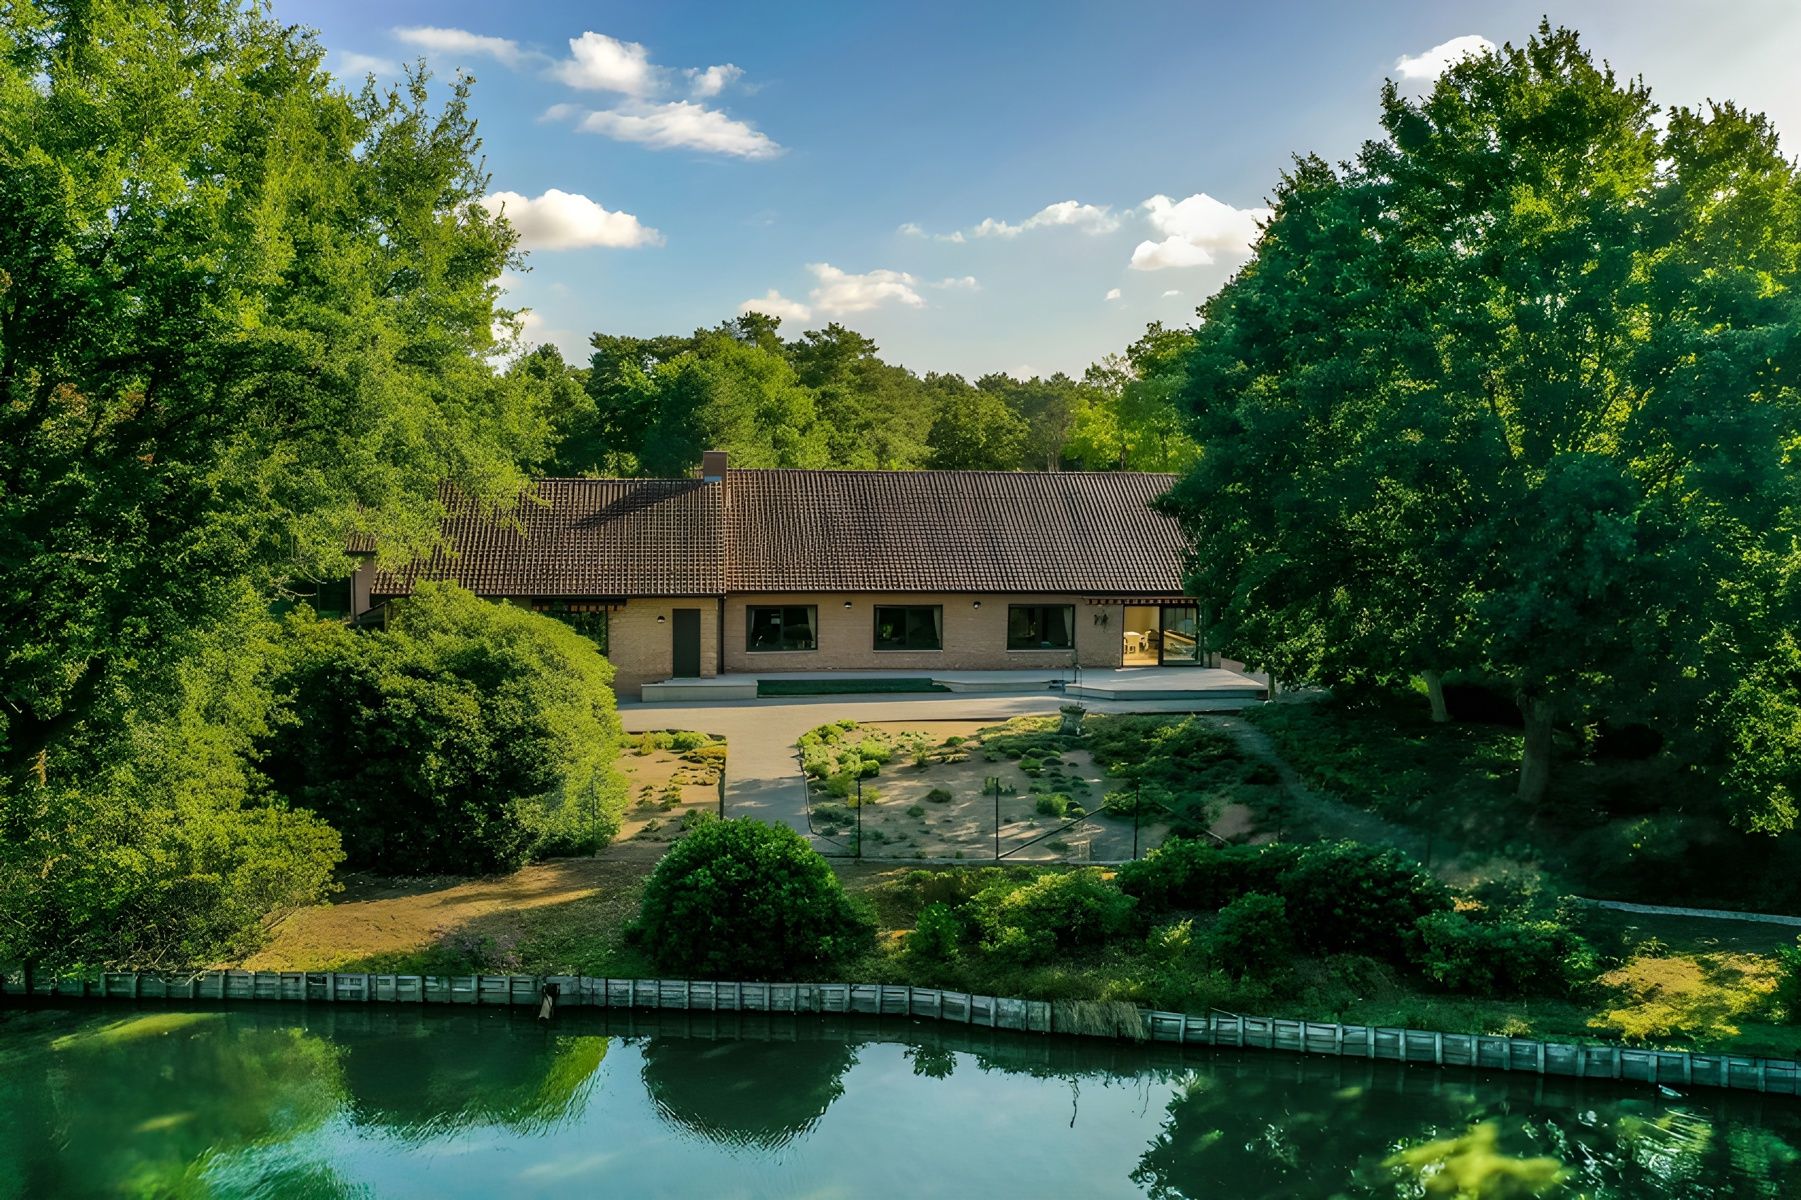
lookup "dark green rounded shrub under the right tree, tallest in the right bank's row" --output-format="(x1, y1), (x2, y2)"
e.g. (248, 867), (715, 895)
(1277, 841), (1452, 962)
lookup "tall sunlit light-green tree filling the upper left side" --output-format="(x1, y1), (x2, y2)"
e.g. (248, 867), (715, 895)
(0, 0), (546, 786)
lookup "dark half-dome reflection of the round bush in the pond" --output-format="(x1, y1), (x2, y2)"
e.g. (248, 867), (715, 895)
(643, 1038), (857, 1150)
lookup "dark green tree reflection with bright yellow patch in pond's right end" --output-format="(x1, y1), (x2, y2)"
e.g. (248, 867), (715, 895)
(1131, 1070), (1801, 1200)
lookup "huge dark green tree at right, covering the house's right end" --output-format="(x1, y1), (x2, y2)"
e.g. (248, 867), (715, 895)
(1172, 25), (1801, 829)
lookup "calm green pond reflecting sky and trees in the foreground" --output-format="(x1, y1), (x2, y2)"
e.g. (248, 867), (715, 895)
(0, 1005), (1801, 1200)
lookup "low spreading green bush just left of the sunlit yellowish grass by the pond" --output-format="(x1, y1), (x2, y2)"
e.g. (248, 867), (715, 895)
(1417, 912), (1596, 996)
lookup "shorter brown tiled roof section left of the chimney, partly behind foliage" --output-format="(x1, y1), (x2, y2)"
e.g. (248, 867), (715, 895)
(371, 479), (724, 596)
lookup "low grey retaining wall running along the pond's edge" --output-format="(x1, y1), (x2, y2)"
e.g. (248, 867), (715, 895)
(4, 971), (1801, 1095)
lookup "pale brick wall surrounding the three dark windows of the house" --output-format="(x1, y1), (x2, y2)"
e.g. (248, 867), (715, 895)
(720, 593), (1124, 672)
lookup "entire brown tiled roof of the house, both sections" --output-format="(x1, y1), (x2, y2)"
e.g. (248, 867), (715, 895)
(371, 470), (1183, 596)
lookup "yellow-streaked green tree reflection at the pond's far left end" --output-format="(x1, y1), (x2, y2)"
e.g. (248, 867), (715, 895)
(0, 1011), (355, 1196)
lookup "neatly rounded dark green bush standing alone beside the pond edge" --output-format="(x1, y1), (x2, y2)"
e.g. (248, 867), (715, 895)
(632, 820), (873, 978)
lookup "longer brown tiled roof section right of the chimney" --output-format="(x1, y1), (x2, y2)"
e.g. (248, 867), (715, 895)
(726, 470), (1183, 595)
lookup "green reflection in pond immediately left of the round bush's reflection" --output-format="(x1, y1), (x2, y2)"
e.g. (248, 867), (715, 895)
(339, 1013), (607, 1135)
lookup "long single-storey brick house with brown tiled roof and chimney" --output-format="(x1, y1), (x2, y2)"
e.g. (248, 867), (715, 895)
(351, 452), (1246, 695)
